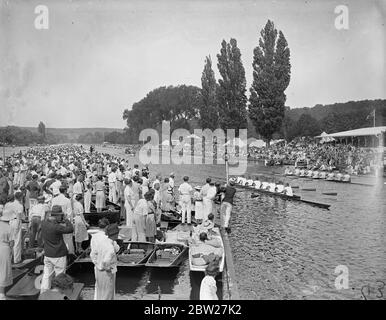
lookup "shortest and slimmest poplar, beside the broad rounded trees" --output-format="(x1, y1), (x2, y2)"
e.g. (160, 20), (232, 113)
(199, 56), (219, 130)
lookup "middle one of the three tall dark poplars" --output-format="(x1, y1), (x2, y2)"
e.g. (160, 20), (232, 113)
(217, 38), (247, 136)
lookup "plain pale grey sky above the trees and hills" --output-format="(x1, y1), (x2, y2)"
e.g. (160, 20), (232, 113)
(0, 0), (386, 128)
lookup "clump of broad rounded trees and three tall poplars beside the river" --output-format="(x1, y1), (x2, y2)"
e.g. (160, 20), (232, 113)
(123, 20), (291, 143)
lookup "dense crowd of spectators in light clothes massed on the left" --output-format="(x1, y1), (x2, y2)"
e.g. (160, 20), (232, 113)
(0, 145), (236, 299)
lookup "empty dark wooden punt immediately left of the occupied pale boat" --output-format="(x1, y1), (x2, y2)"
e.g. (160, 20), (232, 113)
(146, 242), (188, 268)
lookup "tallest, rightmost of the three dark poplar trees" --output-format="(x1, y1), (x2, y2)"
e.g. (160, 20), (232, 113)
(249, 20), (291, 145)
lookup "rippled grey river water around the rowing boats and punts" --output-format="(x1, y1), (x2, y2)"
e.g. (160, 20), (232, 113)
(5, 147), (386, 299)
